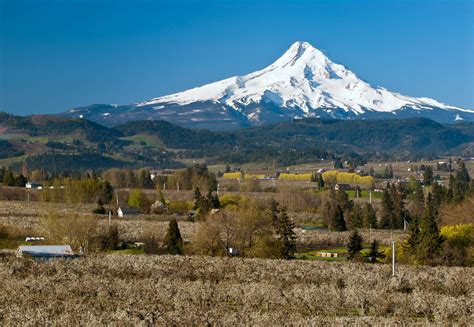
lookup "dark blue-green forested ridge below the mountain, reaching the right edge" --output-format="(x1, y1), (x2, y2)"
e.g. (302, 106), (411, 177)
(117, 118), (474, 154)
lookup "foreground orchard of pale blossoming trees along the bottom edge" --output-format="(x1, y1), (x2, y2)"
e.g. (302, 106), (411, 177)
(0, 255), (474, 326)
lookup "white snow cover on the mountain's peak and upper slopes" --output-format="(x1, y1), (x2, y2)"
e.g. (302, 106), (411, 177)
(140, 42), (468, 115)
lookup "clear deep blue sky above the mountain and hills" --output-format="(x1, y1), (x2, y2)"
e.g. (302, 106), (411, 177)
(0, 0), (474, 115)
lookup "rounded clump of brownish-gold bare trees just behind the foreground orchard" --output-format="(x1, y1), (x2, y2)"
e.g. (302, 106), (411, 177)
(192, 198), (296, 259)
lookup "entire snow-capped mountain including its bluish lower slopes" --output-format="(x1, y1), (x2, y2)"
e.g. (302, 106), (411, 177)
(66, 42), (474, 129)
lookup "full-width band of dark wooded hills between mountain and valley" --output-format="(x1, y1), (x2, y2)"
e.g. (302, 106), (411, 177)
(0, 113), (474, 172)
